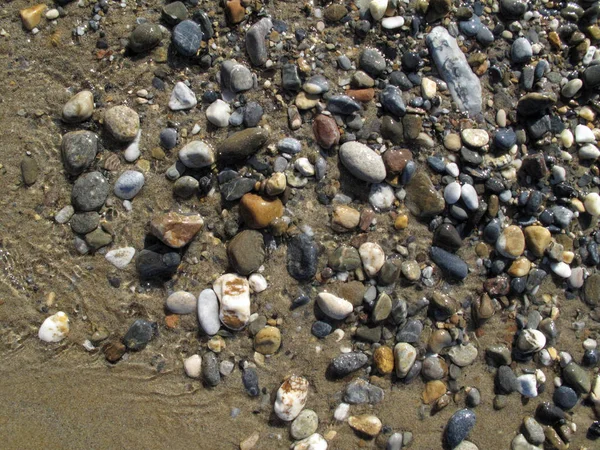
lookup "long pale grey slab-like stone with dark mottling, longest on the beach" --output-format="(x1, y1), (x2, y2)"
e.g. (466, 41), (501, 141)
(426, 26), (481, 115)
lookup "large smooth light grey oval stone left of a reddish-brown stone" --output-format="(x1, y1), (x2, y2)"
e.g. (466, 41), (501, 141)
(339, 141), (386, 183)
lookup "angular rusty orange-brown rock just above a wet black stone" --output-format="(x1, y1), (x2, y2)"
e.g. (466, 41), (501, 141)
(150, 212), (204, 248)
